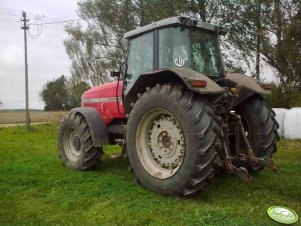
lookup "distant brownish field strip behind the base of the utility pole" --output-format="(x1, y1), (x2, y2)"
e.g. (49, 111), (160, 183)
(0, 111), (66, 124)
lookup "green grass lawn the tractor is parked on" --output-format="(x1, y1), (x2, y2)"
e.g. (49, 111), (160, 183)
(0, 124), (301, 226)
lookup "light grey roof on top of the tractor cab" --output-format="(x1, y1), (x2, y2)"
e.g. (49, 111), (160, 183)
(123, 16), (226, 39)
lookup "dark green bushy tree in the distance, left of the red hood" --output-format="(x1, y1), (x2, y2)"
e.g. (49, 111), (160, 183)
(40, 75), (69, 111)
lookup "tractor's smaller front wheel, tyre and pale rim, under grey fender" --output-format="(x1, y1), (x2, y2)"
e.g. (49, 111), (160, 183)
(58, 112), (102, 170)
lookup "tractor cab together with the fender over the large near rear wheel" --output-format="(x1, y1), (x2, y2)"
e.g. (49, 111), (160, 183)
(119, 17), (226, 113)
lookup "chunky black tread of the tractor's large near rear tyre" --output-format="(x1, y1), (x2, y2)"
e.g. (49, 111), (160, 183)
(128, 84), (220, 196)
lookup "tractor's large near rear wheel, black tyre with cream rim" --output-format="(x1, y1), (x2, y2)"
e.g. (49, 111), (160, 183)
(127, 85), (220, 196)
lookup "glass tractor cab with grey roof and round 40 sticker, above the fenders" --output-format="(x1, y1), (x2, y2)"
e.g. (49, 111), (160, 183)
(124, 17), (226, 81)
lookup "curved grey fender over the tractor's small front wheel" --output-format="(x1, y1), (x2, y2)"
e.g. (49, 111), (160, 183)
(71, 107), (109, 147)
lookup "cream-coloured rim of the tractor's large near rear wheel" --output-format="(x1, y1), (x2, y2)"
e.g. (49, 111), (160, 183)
(136, 109), (185, 179)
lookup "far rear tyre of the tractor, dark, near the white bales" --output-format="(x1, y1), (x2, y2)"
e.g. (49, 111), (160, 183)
(235, 96), (279, 172)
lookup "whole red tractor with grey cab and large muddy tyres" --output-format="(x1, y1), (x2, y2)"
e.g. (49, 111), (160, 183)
(58, 17), (279, 196)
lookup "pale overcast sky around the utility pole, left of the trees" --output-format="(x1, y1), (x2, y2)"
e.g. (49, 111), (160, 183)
(0, 0), (78, 109)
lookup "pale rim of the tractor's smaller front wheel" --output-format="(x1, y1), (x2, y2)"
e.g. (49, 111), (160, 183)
(63, 128), (81, 161)
